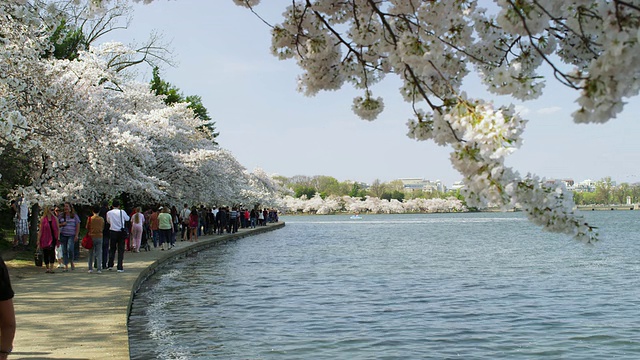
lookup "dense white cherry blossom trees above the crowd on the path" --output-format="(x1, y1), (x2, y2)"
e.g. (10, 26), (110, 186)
(0, 0), (276, 208)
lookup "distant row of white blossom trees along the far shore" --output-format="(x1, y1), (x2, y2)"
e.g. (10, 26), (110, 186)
(278, 194), (468, 215)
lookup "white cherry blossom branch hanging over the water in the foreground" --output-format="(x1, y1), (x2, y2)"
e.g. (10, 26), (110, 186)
(224, 0), (640, 242)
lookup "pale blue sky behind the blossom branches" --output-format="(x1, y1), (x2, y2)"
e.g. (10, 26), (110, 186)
(102, 0), (640, 186)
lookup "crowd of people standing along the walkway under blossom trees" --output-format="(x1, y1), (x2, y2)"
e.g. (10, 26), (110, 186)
(18, 199), (278, 273)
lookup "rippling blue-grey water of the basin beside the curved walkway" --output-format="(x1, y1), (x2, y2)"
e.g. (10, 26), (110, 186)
(129, 211), (640, 359)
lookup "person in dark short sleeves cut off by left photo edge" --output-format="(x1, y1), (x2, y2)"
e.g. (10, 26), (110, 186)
(0, 257), (16, 360)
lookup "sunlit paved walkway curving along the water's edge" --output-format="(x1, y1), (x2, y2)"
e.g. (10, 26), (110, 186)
(9, 222), (284, 359)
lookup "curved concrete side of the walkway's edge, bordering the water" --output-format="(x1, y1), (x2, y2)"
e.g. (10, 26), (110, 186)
(127, 222), (285, 328)
